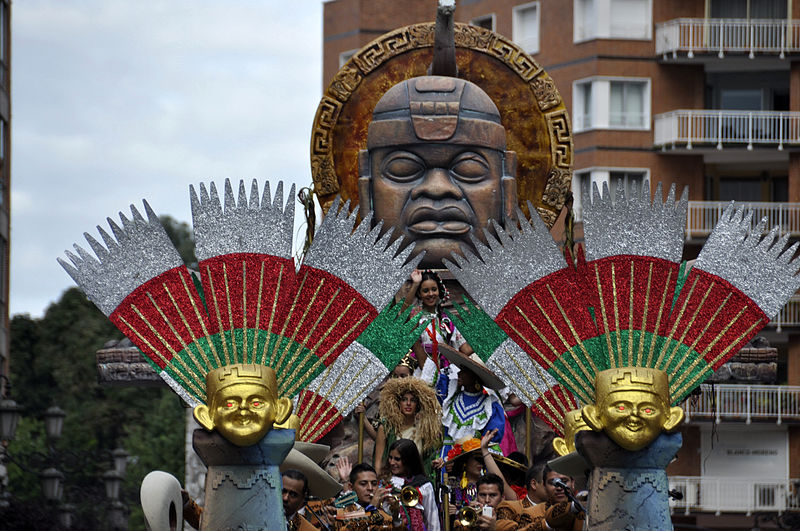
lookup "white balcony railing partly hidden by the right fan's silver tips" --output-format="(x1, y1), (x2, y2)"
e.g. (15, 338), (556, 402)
(686, 201), (800, 240)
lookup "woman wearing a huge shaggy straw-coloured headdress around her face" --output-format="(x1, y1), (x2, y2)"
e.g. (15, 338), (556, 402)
(373, 378), (442, 479)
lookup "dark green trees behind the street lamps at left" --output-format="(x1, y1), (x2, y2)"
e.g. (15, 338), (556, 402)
(6, 288), (184, 529)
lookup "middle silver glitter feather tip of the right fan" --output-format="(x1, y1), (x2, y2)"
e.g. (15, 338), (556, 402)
(583, 181), (689, 262)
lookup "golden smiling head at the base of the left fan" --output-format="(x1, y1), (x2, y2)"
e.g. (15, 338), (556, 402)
(194, 363), (292, 446)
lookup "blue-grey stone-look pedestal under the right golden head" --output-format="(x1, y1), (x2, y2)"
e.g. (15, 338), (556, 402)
(575, 431), (682, 531)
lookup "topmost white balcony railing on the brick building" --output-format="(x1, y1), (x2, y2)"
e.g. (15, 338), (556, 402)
(656, 18), (800, 59)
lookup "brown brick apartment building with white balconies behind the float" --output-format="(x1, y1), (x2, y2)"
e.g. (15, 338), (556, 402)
(323, 0), (800, 529)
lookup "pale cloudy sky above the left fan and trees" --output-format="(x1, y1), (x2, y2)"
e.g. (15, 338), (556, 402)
(10, 0), (322, 317)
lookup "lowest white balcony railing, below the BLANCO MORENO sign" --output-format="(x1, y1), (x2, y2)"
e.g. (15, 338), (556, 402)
(669, 476), (800, 515)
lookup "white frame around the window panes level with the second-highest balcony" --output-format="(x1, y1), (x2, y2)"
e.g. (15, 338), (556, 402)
(572, 76), (652, 133)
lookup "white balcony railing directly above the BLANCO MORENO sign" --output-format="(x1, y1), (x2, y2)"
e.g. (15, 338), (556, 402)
(681, 384), (800, 424)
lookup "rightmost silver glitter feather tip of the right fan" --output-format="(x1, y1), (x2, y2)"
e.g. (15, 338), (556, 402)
(693, 205), (800, 318)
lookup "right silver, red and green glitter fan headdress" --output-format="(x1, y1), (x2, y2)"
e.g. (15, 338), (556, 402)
(447, 184), (800, 420)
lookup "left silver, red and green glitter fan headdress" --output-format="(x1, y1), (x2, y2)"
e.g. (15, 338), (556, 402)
(59, 180), (419, 441)
